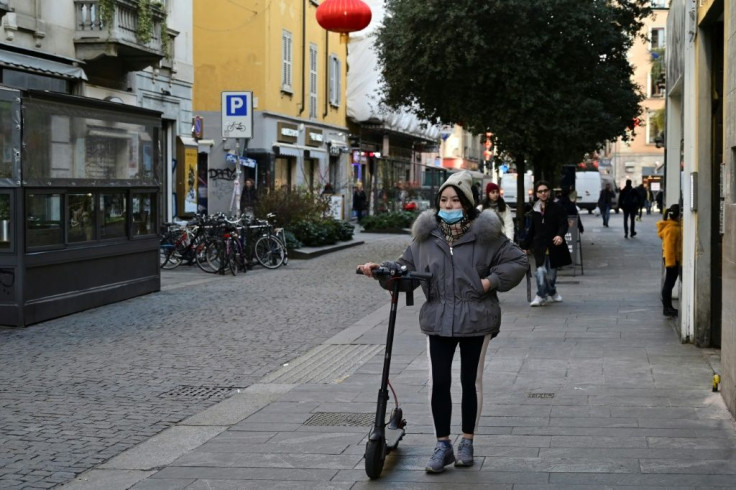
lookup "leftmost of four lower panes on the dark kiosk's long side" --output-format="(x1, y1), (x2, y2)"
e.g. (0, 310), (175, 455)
(26, 193), (64, 248)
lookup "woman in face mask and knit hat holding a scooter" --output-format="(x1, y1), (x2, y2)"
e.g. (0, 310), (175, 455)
(358, 171), (527, 473)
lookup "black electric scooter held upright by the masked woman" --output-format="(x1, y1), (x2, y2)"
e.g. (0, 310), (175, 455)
(356, 266), (432, 479)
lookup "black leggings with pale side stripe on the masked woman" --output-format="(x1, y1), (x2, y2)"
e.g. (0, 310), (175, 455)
(427, 335), (491, 438)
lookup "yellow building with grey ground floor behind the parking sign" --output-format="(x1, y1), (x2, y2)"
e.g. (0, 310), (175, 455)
(190, 0), (349, 213)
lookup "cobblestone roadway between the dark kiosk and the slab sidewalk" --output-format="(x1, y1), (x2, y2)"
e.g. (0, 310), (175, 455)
(0, 235), (409, 489)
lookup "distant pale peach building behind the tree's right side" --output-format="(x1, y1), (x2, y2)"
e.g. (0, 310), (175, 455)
(601, 5), (668, 192)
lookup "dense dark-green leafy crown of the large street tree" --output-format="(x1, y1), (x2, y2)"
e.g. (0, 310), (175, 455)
(376, 0), (650, 218)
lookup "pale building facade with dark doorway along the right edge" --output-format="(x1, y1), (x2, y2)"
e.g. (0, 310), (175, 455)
(665, 0), (736, 414)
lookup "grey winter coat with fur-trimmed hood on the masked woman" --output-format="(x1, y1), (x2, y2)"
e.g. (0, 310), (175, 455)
(386, 210), (528, 337)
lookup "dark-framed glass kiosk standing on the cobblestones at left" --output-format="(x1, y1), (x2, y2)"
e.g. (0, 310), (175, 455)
(0, 87), (161, 326)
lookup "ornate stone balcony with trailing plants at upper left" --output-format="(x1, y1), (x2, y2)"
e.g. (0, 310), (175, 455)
(74, 0), (166, 71)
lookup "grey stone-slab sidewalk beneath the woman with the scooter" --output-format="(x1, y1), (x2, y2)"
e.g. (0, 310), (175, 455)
(44, 216), (736, 490)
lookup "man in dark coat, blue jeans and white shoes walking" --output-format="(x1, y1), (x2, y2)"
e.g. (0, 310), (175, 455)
(520, 180), (572, 306)
